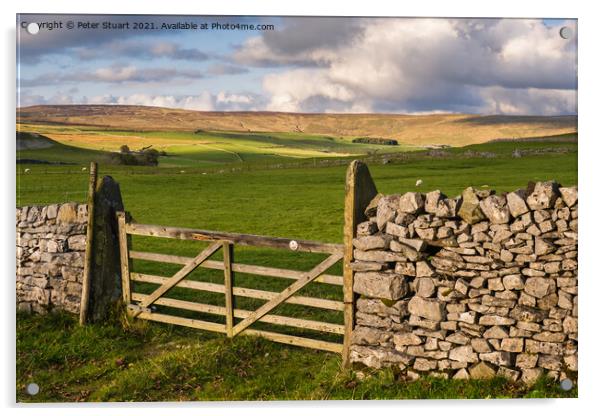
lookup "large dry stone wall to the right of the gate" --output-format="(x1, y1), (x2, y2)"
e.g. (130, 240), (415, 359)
(350, 181), (578, 383)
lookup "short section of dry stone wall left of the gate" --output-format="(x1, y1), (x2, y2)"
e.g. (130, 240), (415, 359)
(16, 203), (88, 313)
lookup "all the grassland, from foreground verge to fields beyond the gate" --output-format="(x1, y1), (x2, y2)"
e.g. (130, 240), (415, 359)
(17, 112), (577, 401)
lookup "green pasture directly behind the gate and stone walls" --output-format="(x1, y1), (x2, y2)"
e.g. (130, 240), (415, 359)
(17, 136), (577, 338)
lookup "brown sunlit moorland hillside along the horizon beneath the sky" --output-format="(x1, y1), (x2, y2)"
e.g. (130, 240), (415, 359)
(17, 105), (577, 146)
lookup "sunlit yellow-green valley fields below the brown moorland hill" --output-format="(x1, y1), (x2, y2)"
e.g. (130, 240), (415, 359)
(18, 124), (421, 168)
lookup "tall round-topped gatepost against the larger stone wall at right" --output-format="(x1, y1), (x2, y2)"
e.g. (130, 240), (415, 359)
(342, 160), (377, 367)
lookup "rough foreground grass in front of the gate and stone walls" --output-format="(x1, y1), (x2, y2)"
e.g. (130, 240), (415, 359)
(17, 313), (578, 402)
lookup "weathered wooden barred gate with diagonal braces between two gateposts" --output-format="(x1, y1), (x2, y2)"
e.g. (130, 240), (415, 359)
(117, 212), (345, 353)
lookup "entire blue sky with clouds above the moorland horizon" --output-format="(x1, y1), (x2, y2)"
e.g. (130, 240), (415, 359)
(17, 14), (577, 115)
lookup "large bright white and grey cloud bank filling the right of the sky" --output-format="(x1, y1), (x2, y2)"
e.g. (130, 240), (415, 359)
(233, 18), (576, 114)
